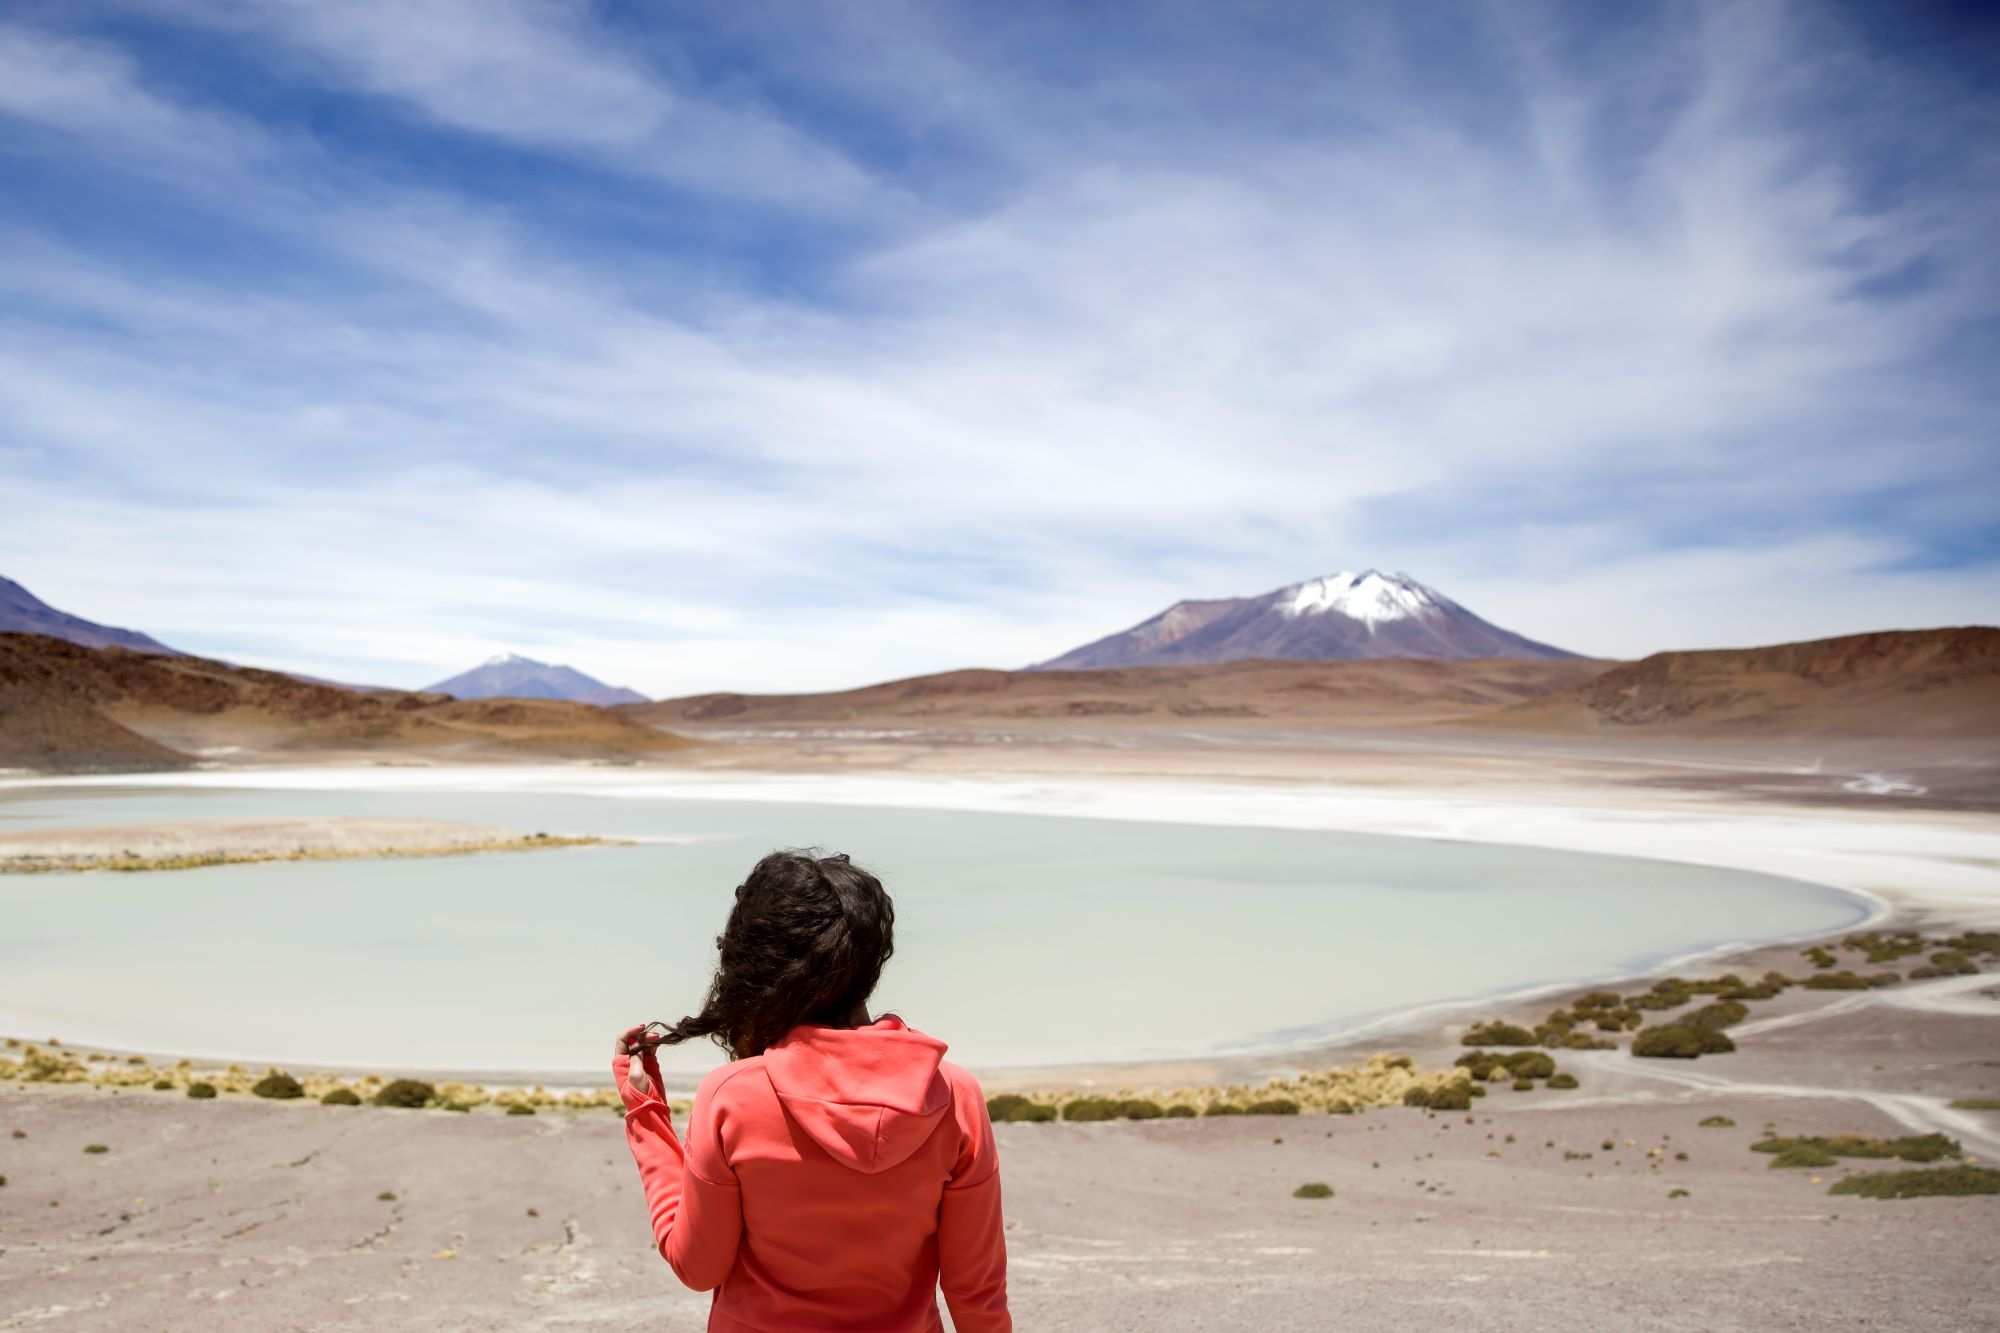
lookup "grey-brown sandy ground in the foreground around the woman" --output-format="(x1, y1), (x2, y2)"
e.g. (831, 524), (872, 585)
(0, 977), (2000, 1331)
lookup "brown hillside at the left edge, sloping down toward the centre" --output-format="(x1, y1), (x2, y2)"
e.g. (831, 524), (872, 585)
(0, 634), (690, 773)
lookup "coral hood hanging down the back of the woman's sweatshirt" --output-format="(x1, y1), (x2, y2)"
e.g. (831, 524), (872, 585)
(764, 1015), (952, 1175)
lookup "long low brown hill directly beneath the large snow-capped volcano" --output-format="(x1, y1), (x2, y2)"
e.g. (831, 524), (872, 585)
(618, 660), (1606, 727)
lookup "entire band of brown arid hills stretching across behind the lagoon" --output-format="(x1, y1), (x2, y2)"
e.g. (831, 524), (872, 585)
(0, 626), (2000, 773)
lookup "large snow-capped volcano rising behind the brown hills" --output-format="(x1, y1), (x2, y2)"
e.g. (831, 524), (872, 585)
(1030, 568), (1576, 671)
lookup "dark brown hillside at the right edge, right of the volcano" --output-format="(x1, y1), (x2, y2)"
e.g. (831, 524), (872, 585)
(1476, 626), (2000, 739)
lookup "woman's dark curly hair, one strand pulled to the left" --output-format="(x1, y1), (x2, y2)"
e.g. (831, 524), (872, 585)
(660, 851), (896, 1059)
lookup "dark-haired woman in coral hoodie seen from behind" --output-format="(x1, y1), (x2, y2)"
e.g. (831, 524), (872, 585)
(612, 853), (1014, 1333)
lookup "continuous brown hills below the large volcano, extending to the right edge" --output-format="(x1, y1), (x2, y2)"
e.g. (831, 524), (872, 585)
(636, 626), (2000, 739)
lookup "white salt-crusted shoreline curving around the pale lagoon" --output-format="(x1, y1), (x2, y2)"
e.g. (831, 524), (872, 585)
(0, 743), (2000, 1091)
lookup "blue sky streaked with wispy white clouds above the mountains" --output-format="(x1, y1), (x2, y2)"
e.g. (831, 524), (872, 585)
(0, 0), (2000, 695)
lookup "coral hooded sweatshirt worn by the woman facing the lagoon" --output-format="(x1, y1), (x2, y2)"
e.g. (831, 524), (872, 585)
(612, 1015), (1014, 1333)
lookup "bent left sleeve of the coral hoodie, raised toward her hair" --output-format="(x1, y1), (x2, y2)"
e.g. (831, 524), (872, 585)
(612, 1051), (744, 1291)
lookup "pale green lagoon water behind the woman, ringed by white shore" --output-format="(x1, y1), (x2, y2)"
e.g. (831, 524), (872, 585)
(0, 785), (1868, 1073)
